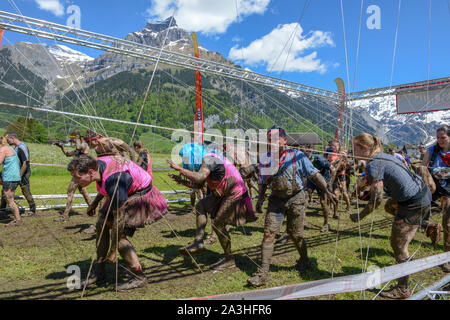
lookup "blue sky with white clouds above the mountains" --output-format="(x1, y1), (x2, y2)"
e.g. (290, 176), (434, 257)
(0, 0), (450, 91)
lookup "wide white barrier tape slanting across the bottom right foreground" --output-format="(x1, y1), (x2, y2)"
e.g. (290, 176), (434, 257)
(190, 252), (450, 300)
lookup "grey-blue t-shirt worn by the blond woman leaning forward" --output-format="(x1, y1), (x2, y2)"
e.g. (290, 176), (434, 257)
(366, 153), (422, 202)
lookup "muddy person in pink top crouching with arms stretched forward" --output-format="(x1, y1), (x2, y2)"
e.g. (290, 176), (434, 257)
(167, 144), (257, 270)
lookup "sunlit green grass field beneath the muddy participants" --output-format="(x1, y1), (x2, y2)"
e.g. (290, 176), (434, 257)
(0, 144), (443, 300)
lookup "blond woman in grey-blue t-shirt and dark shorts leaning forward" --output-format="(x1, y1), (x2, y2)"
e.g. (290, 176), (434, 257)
(350, 133), (436, 299)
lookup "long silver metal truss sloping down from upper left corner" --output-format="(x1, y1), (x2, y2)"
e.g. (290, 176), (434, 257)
(0, 11), (339, 102)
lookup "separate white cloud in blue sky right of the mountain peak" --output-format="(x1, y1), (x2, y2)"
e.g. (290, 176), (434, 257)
(228, 23), (335, 73)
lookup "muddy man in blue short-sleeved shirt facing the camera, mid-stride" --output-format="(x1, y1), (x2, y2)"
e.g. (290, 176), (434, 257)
(247, 126), (336, 287)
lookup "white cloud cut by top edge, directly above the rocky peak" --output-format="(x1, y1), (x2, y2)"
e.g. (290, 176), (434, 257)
(146, 0), (270, 34)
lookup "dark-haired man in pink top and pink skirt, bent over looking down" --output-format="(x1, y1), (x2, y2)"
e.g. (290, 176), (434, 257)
(68, 155), (167, 291)
